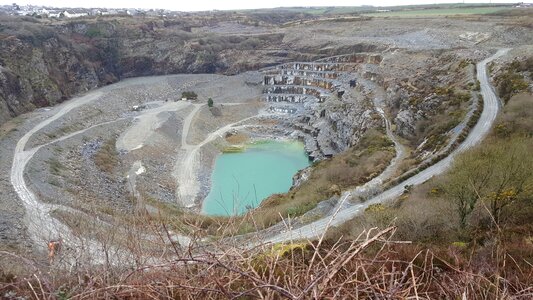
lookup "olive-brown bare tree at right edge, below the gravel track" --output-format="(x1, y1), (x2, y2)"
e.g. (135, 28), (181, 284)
(443, 138), (533, 228)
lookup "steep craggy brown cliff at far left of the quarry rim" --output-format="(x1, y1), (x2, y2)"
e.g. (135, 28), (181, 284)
(0, 21), (120, 124)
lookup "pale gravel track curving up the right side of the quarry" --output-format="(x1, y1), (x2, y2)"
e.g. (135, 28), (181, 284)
(263, 49), (510, 243)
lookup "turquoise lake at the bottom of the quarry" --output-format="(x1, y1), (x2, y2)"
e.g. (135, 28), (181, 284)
(202, 141), (309, 216)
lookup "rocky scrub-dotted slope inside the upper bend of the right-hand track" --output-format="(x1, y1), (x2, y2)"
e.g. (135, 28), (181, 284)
(380, 50), (475, 148)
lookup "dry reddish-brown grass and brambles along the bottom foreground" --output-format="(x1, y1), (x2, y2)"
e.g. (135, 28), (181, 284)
(0, 227), (533, 300)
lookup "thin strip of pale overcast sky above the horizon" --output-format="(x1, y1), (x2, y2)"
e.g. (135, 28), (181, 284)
(0, 0), (531, 11)
